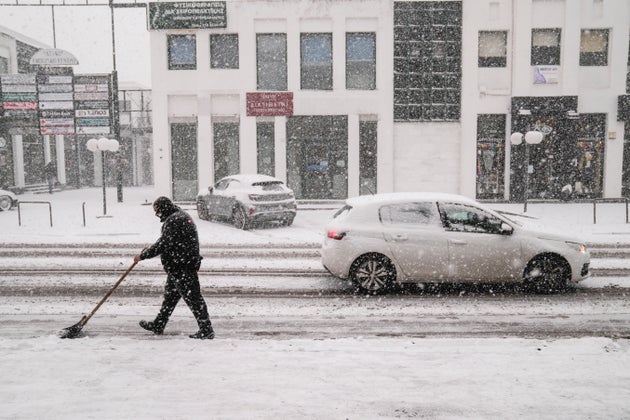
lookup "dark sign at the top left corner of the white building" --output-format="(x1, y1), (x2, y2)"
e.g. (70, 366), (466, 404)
(147, 1), (227, 30)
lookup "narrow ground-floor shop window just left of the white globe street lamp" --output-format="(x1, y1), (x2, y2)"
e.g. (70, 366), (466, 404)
(477, 114), (505, 199)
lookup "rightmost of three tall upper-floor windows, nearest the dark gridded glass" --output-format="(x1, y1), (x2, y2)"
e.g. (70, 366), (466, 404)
(346, 32), (376, 90)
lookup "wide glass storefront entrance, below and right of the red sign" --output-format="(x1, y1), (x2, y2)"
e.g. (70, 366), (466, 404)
(287, 116), (348, 199)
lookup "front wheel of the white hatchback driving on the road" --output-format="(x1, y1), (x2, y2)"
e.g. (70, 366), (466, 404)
(523, 255), (571, 293)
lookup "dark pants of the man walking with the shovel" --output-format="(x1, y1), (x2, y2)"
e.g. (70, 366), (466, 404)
(155, 270), (212, 332)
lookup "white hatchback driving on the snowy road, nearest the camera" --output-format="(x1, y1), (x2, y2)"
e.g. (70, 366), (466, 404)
(321, 193), (590, 292)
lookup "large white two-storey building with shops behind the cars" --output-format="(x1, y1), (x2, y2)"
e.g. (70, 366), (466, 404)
(148, 0), (630, 200)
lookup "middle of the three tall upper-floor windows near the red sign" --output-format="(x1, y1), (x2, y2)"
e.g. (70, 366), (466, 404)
(300, 34), (332, 90)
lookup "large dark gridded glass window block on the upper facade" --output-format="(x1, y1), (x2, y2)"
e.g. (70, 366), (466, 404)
(394, 1), (462, 121)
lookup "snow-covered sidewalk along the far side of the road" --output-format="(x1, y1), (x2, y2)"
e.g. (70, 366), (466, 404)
(0, 187), (630, 246)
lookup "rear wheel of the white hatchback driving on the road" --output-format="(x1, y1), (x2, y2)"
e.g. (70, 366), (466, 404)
(350, 253), (396, 293)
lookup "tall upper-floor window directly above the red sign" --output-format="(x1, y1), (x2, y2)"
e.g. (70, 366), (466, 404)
(256, 34), (287, 91)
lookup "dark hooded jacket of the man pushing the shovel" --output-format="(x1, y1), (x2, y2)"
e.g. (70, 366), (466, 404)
(140, 197), (202, 273)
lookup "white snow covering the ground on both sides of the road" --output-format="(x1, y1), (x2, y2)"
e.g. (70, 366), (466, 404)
(0, 188), (630, 419)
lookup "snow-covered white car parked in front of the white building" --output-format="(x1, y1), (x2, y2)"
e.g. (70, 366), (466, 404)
(197, 175), (297, 229)
